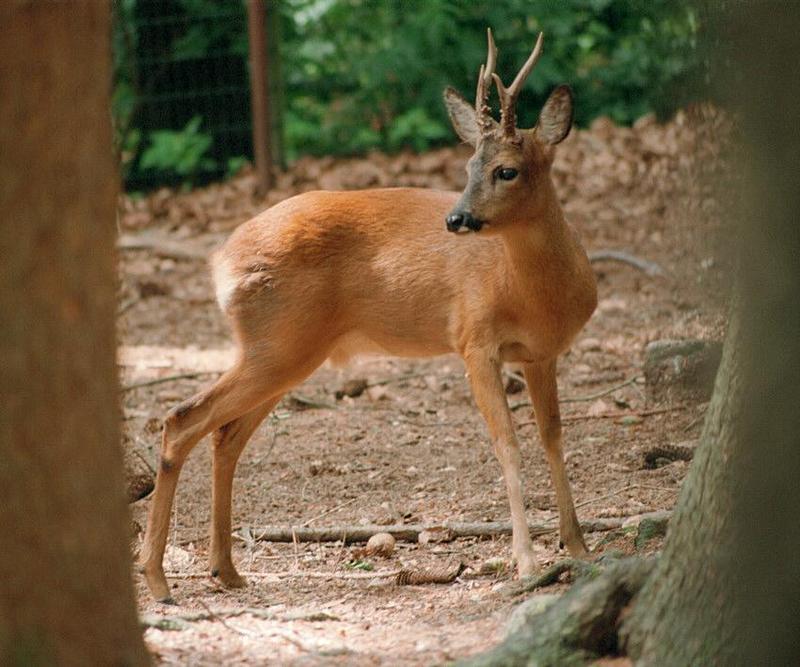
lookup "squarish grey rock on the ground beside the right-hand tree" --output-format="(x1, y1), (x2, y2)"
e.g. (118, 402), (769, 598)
(644, 340), (722, 403)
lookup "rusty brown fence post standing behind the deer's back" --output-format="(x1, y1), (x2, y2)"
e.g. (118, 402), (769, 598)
(247, 0), (272, 195)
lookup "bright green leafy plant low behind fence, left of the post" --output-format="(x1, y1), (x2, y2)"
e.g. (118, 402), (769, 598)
(139, 116), (217, 180)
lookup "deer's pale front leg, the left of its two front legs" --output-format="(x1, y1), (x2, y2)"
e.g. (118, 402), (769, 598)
(464, 350), (536, 576)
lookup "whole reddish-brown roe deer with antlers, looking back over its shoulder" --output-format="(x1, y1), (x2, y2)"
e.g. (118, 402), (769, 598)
(141, 31), (597, 601)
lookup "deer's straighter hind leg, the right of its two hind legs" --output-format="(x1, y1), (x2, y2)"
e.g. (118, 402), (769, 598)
(210, 395), (280, 588)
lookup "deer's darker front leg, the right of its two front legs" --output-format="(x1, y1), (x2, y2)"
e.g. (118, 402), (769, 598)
(523, 359), (588, 558)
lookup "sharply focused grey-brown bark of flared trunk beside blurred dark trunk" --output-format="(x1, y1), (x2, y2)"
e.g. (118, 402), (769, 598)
(623, 308), (744, 665)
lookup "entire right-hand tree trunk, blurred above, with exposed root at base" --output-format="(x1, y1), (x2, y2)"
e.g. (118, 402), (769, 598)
(462, 3), (800, 666)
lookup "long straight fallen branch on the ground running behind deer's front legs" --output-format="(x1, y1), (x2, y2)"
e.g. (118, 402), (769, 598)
(244, 514), (668, 544)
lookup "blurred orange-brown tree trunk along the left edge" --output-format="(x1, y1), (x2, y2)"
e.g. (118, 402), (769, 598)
(0, 2), (148, 665)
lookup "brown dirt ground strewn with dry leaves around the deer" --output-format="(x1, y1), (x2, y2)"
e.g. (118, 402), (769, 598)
(119, 108), (727, 665)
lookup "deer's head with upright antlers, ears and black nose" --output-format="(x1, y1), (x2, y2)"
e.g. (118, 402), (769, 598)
(444, 29), (573, 232)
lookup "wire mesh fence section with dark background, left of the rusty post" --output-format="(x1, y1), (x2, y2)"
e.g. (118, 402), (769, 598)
(114, 0), (253, 189)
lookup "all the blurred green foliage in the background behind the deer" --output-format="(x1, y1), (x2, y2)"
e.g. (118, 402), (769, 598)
(113, 0), (703, 183)
